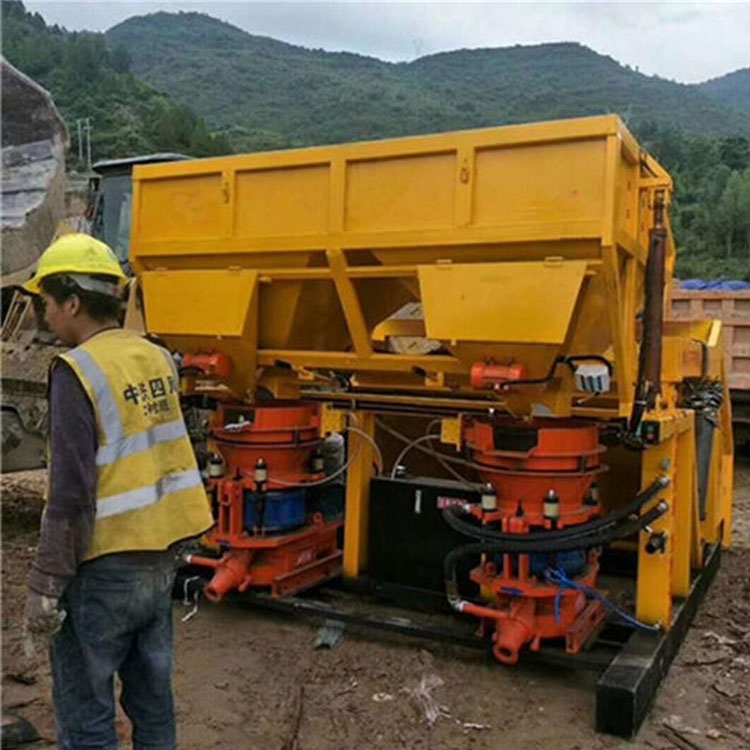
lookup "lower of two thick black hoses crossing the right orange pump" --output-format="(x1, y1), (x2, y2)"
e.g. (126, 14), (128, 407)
(445, 501), (669, 583)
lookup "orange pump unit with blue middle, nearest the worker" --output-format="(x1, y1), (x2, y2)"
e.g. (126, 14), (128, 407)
(187, 401), (342, 601)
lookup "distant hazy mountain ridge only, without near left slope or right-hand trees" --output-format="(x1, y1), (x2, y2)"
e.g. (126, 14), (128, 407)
(107, 13), (750, 150)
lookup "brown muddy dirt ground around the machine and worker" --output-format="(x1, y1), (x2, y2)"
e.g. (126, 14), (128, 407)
(2, 459), (750, 750)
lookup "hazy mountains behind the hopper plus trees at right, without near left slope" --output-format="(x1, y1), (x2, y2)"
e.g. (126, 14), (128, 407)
(107, 13), (750, 278)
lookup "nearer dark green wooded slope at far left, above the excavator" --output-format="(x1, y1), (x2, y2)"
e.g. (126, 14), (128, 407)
(2, 0), (231, 159)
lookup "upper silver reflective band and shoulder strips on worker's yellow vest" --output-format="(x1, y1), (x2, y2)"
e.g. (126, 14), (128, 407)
(68, 349), (187, 470)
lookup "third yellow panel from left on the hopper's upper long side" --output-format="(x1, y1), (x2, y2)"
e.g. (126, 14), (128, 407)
(345, 153), (456, 232)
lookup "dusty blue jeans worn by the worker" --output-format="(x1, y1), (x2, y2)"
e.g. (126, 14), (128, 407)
(50, 552), (175, 750)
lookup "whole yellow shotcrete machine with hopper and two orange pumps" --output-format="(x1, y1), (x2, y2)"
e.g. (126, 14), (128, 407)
(131, 116), (732, 736)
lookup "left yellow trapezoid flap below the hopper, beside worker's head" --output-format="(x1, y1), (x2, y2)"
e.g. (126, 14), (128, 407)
(141, 270), (258, 336)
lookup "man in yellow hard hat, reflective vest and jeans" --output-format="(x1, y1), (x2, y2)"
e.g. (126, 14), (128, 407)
(24, 234), (212, 750)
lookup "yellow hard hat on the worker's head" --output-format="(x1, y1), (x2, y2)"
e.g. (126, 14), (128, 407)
(23, 233), (127, 294)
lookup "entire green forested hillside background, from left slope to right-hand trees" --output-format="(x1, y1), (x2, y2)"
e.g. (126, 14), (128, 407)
(2, 2), (750, 279)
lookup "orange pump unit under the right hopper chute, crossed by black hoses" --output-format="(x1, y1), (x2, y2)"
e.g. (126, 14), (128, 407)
(455, 419), (605, 664)
